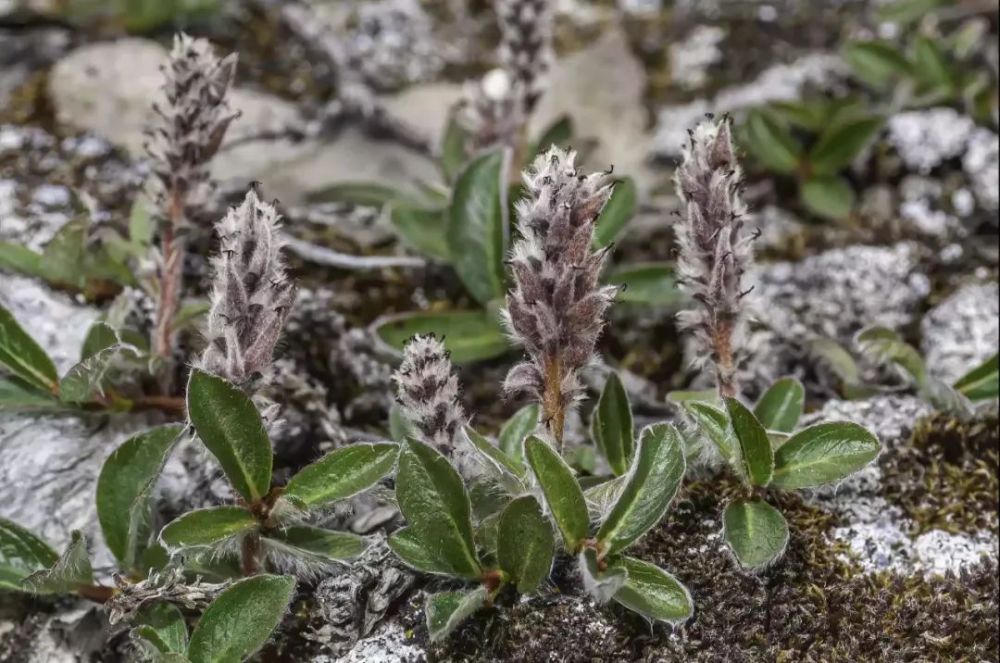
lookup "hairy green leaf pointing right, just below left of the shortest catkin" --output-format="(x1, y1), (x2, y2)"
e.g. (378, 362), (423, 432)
(282, 442), (399, 508)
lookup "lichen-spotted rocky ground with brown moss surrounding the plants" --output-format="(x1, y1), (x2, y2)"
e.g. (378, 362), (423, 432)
(0, 0), (1000, 663)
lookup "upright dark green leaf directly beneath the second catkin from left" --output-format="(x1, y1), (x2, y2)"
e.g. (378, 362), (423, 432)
(187, 369), (273, 503)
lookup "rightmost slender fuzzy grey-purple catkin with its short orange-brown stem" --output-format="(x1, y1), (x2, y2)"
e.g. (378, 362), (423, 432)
(676, 118), (755, 397)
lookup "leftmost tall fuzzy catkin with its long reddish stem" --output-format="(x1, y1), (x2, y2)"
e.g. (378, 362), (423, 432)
(147, 34), (238, 382)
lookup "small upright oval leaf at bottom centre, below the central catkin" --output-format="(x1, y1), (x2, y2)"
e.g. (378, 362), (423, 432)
(497, 495), (555, 594)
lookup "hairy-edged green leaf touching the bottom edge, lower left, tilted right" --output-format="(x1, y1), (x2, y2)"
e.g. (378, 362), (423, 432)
(188, 575), (295, 663)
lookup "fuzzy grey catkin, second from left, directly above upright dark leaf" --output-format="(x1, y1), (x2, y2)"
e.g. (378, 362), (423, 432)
(199, 185), (295, 385)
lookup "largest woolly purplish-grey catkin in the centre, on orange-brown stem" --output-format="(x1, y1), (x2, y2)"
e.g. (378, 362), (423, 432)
(504, 147), (617, 445)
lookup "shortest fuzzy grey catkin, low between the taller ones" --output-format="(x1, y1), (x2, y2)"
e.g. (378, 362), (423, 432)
(392, 335), (478, 478)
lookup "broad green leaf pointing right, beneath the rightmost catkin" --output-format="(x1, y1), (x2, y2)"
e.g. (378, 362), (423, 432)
(771, 421), (880, 490)
